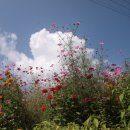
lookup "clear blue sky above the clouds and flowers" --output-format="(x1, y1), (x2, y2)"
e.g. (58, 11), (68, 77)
(0, 0), (130, 67)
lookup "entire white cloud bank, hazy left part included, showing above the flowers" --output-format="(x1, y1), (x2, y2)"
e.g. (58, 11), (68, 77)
(0, 29), (94, 74)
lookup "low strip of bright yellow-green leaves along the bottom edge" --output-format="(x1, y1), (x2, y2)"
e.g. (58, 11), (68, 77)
(33, 116), (130, 130)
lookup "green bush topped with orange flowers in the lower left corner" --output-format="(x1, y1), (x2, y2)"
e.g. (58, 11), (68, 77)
(0, 71), (34, 130)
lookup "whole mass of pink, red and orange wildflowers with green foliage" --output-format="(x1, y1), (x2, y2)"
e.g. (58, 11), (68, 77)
(0, 22), (130, 130)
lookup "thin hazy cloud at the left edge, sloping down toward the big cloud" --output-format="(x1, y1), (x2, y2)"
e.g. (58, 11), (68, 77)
(0, 33), (32, 67)
